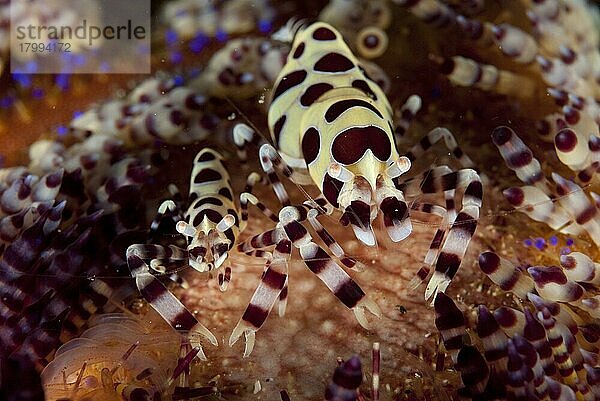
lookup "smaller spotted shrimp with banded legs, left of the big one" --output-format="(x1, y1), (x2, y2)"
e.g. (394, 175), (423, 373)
(127, 148), (245, 358)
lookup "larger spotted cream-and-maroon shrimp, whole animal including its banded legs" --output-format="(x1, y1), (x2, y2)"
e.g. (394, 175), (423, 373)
(229, 22), (482, 355)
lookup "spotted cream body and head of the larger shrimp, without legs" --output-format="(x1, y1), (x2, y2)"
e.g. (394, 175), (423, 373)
(262, 23), (411, 246)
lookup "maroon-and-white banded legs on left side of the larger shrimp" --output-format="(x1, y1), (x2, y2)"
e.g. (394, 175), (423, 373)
(229, 135), (381, 357)
